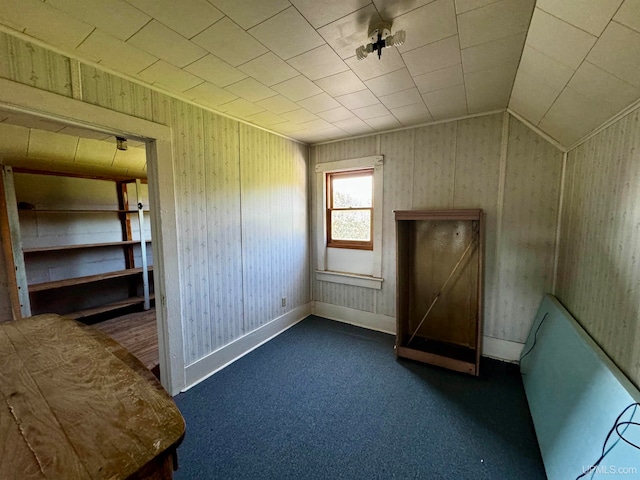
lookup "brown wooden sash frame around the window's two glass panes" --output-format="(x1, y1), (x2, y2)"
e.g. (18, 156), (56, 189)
(325, 167), (375, 250)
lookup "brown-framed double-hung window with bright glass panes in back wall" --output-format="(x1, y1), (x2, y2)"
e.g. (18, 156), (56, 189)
(326, 168), (373, 250)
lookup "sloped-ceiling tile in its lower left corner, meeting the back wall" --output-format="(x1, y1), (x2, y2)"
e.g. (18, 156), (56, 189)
(509, 71), (561, 125)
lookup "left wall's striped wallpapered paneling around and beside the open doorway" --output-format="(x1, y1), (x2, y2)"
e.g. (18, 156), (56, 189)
(0, 33), (311, 365)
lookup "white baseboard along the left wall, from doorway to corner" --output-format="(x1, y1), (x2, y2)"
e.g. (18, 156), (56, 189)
(182, 303), (311, 392)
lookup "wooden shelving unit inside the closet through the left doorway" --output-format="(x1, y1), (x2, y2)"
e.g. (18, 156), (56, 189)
(3, 167), (154, 319)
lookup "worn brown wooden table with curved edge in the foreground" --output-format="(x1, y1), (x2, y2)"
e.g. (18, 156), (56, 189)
(0, 315), (185, 480)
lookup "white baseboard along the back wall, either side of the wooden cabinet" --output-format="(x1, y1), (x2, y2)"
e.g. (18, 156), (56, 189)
(311, 302), (524, 363)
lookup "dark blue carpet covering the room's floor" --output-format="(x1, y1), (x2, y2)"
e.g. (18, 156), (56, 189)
(175, 316), (546, 480)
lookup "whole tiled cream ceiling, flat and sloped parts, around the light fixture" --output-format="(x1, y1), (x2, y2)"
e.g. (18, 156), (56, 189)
(0, 0), (640, 146)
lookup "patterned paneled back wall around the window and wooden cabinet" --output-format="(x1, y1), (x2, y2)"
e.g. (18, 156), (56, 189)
(311, 114), (562, 343)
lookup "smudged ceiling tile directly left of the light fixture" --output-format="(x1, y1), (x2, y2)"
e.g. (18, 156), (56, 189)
(318, 4), (382, 59)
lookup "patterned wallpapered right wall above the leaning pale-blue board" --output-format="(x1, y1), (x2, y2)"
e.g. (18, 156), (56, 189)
(557, 110), (640, 386)
